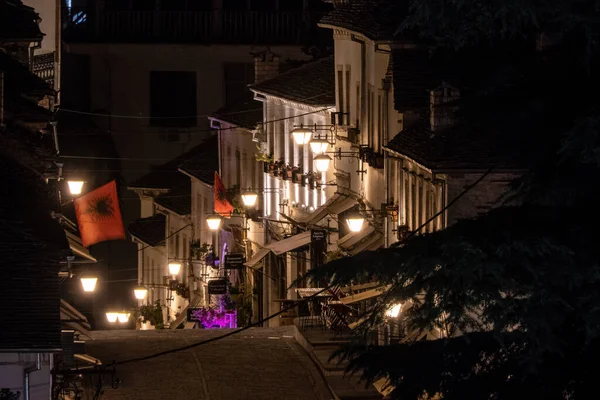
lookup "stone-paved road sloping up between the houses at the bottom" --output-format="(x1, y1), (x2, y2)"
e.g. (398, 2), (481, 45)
(87, 327), (332, 400)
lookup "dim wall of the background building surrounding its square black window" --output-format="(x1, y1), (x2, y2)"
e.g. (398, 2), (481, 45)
(66, 43), (306, 181)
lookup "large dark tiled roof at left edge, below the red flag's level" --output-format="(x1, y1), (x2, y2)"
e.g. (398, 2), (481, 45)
(0, 156), (68, 352)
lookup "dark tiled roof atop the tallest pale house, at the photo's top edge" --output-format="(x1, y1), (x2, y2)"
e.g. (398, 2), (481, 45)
(319, 0), (408, 40)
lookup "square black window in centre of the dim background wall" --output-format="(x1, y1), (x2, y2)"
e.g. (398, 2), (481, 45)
(150, 71), (196, 127)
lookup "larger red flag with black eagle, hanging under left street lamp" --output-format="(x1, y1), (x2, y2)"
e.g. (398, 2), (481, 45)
(75, 181), (125, 247)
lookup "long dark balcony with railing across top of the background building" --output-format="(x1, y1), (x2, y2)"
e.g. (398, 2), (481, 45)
(65, 8), (318, 45)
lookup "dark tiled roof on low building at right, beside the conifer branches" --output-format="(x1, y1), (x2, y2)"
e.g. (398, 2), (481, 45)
(385, 118), (524, 170)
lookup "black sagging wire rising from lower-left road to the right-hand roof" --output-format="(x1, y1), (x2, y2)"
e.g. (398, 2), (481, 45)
(109, 167), (493, 365)
